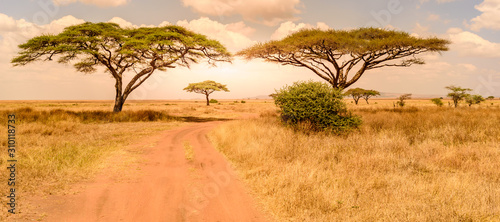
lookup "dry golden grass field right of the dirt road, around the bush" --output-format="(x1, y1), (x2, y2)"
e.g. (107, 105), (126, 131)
(210, 105), (500, 221)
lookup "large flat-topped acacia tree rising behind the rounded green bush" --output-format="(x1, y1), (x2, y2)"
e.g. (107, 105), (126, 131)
(237, 28), (450, 89)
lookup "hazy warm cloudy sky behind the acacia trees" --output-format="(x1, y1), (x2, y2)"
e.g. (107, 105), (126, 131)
(0, 0), (500, 100)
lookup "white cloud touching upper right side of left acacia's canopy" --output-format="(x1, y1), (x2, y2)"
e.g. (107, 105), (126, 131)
(177, 17), (255, 52)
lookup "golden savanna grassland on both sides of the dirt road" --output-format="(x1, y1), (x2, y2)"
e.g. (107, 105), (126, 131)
(0, 99), (500, 221)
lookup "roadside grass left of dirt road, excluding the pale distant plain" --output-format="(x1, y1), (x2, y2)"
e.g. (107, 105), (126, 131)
(0, 108), (182, 218)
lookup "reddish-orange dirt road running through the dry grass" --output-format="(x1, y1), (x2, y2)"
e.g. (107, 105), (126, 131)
(27, 122), (266, 221)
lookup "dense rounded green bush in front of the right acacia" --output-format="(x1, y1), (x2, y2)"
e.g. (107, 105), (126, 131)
(274, 81), (361, 132)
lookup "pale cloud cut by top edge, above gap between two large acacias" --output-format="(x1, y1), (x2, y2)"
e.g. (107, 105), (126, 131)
(182, 0), (300, 26)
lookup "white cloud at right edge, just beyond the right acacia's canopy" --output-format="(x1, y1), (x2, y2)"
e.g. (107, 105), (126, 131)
(447, 28), (500, 58)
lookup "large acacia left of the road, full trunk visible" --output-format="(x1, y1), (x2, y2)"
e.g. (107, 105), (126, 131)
(11, 22), (230, 112)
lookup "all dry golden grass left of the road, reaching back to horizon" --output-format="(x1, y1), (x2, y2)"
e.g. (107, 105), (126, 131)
(0, 100), (270, 199)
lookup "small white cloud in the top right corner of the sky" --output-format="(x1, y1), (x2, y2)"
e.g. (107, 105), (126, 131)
(470, 0), (500, 31)
